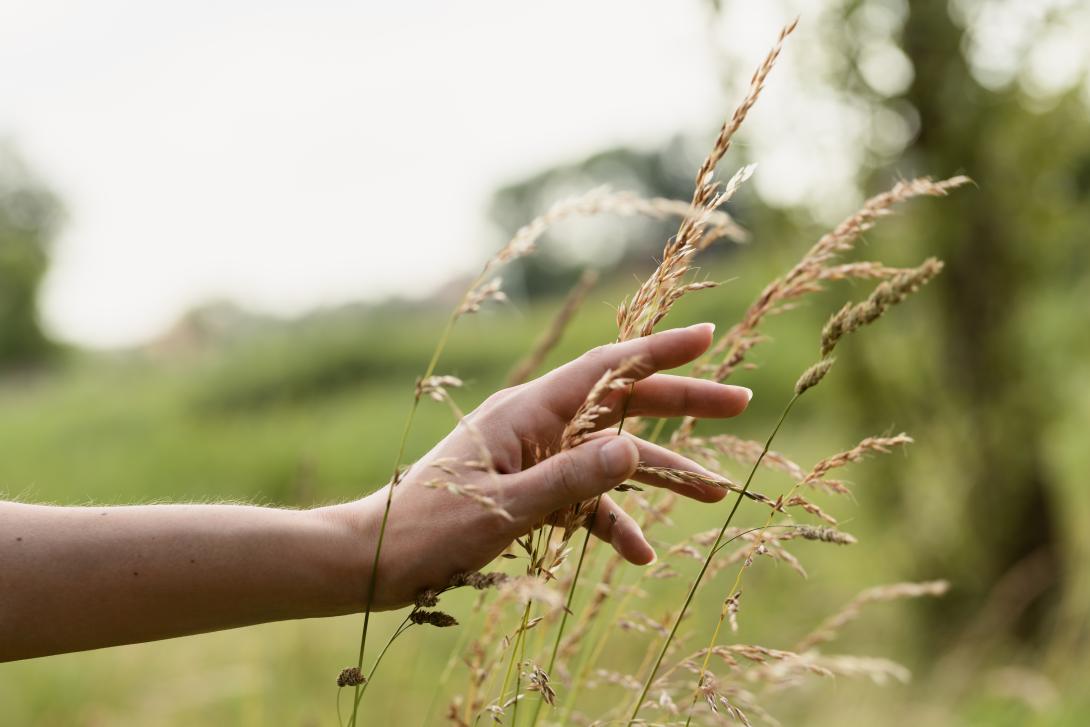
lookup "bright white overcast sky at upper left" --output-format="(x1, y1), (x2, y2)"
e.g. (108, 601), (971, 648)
(0, 0), (782, 346)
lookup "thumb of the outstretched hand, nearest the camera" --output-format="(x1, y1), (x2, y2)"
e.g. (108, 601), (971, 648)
(504, 436), (640, 520)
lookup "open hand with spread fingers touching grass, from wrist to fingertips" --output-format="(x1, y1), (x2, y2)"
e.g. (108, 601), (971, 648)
(329, 324), (751, 608)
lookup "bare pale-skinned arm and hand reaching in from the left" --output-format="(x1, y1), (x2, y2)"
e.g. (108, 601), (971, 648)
(0, 324), (751, 661)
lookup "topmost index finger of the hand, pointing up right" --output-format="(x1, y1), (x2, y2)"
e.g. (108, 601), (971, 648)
(533, 323), (715, 416)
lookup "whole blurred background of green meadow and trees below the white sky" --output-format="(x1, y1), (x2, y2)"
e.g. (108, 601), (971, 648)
(0, 0), (1090, 727)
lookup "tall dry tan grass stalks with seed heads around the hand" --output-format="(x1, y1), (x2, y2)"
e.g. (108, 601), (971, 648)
(339, 18), (968, 727)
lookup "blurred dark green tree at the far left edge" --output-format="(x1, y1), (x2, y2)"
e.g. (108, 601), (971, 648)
(0, 146), (61, 368)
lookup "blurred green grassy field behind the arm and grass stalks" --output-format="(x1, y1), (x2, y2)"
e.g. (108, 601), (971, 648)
(0, 244), (1090, 725)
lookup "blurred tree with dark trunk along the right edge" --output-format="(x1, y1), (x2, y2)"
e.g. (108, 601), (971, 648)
(871, 2), (1090, 637)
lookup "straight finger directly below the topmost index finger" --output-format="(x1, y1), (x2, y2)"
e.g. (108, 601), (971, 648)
(598, 374), (753, 426)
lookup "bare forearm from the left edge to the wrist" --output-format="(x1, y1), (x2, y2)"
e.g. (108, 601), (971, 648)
(0, 502), (367, 661)
